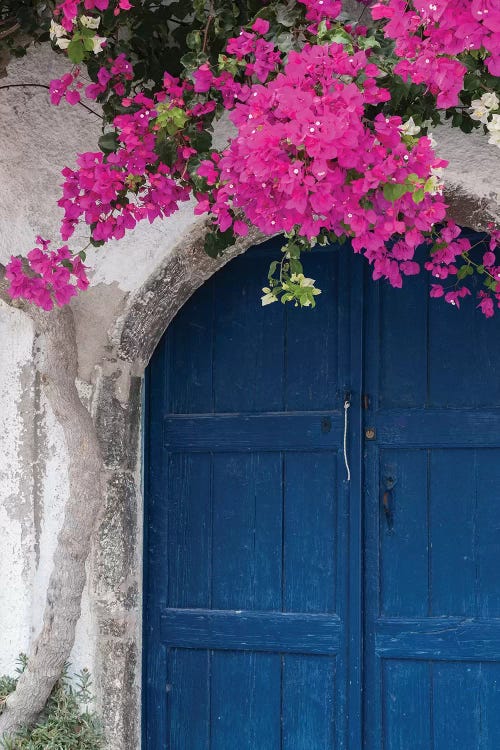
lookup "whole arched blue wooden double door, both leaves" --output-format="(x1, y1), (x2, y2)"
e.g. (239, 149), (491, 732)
(144, 232), (500, 750)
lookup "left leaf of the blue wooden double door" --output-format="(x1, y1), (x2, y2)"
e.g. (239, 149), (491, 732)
(145, 243), (361, 750)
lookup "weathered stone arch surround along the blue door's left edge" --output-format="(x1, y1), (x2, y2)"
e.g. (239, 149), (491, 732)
(88, 221), (263, 750)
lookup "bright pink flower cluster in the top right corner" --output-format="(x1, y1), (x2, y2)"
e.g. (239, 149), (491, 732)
(372, 0), (500, 108)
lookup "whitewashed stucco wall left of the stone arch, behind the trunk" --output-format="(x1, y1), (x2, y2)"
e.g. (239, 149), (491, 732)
(0, 41), (203, 716)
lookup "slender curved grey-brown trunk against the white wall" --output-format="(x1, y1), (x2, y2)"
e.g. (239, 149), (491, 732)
(0, 284), (104, 737)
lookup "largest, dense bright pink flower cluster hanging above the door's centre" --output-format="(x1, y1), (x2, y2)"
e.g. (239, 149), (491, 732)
(198, 44), (458, 286)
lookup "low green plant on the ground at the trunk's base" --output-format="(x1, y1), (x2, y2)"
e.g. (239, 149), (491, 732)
(0, 654), (104, 750)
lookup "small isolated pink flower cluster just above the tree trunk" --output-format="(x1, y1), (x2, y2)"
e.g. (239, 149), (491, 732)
(5, 237), (89, 310)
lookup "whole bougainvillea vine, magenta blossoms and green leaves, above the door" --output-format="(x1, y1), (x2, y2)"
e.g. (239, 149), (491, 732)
(2, 0), (500, 317)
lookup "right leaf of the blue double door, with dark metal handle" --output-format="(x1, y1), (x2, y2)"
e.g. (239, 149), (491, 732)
(365, 258), (500, 750)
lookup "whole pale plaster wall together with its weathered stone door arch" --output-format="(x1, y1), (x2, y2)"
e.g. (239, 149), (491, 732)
(0, 41), (500, 750)
